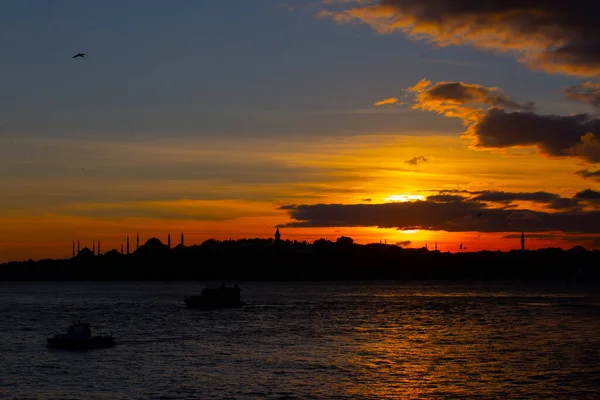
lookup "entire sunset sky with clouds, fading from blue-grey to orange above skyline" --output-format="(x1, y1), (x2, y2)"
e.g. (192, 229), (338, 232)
(0, 0), (600, 261)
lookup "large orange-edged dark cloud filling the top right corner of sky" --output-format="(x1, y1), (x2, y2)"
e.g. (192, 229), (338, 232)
(318, 0), (600, 77)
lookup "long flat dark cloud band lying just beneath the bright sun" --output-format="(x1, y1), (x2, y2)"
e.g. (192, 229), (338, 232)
(280, 192), (600, 234)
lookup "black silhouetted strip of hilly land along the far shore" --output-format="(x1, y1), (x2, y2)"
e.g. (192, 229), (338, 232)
(0, 237), (600, 281)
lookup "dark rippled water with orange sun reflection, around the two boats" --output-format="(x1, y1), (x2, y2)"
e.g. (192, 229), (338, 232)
(0, 282), (600, 399)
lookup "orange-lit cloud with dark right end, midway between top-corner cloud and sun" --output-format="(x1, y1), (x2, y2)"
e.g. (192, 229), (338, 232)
(400, 79), (600, 163)
